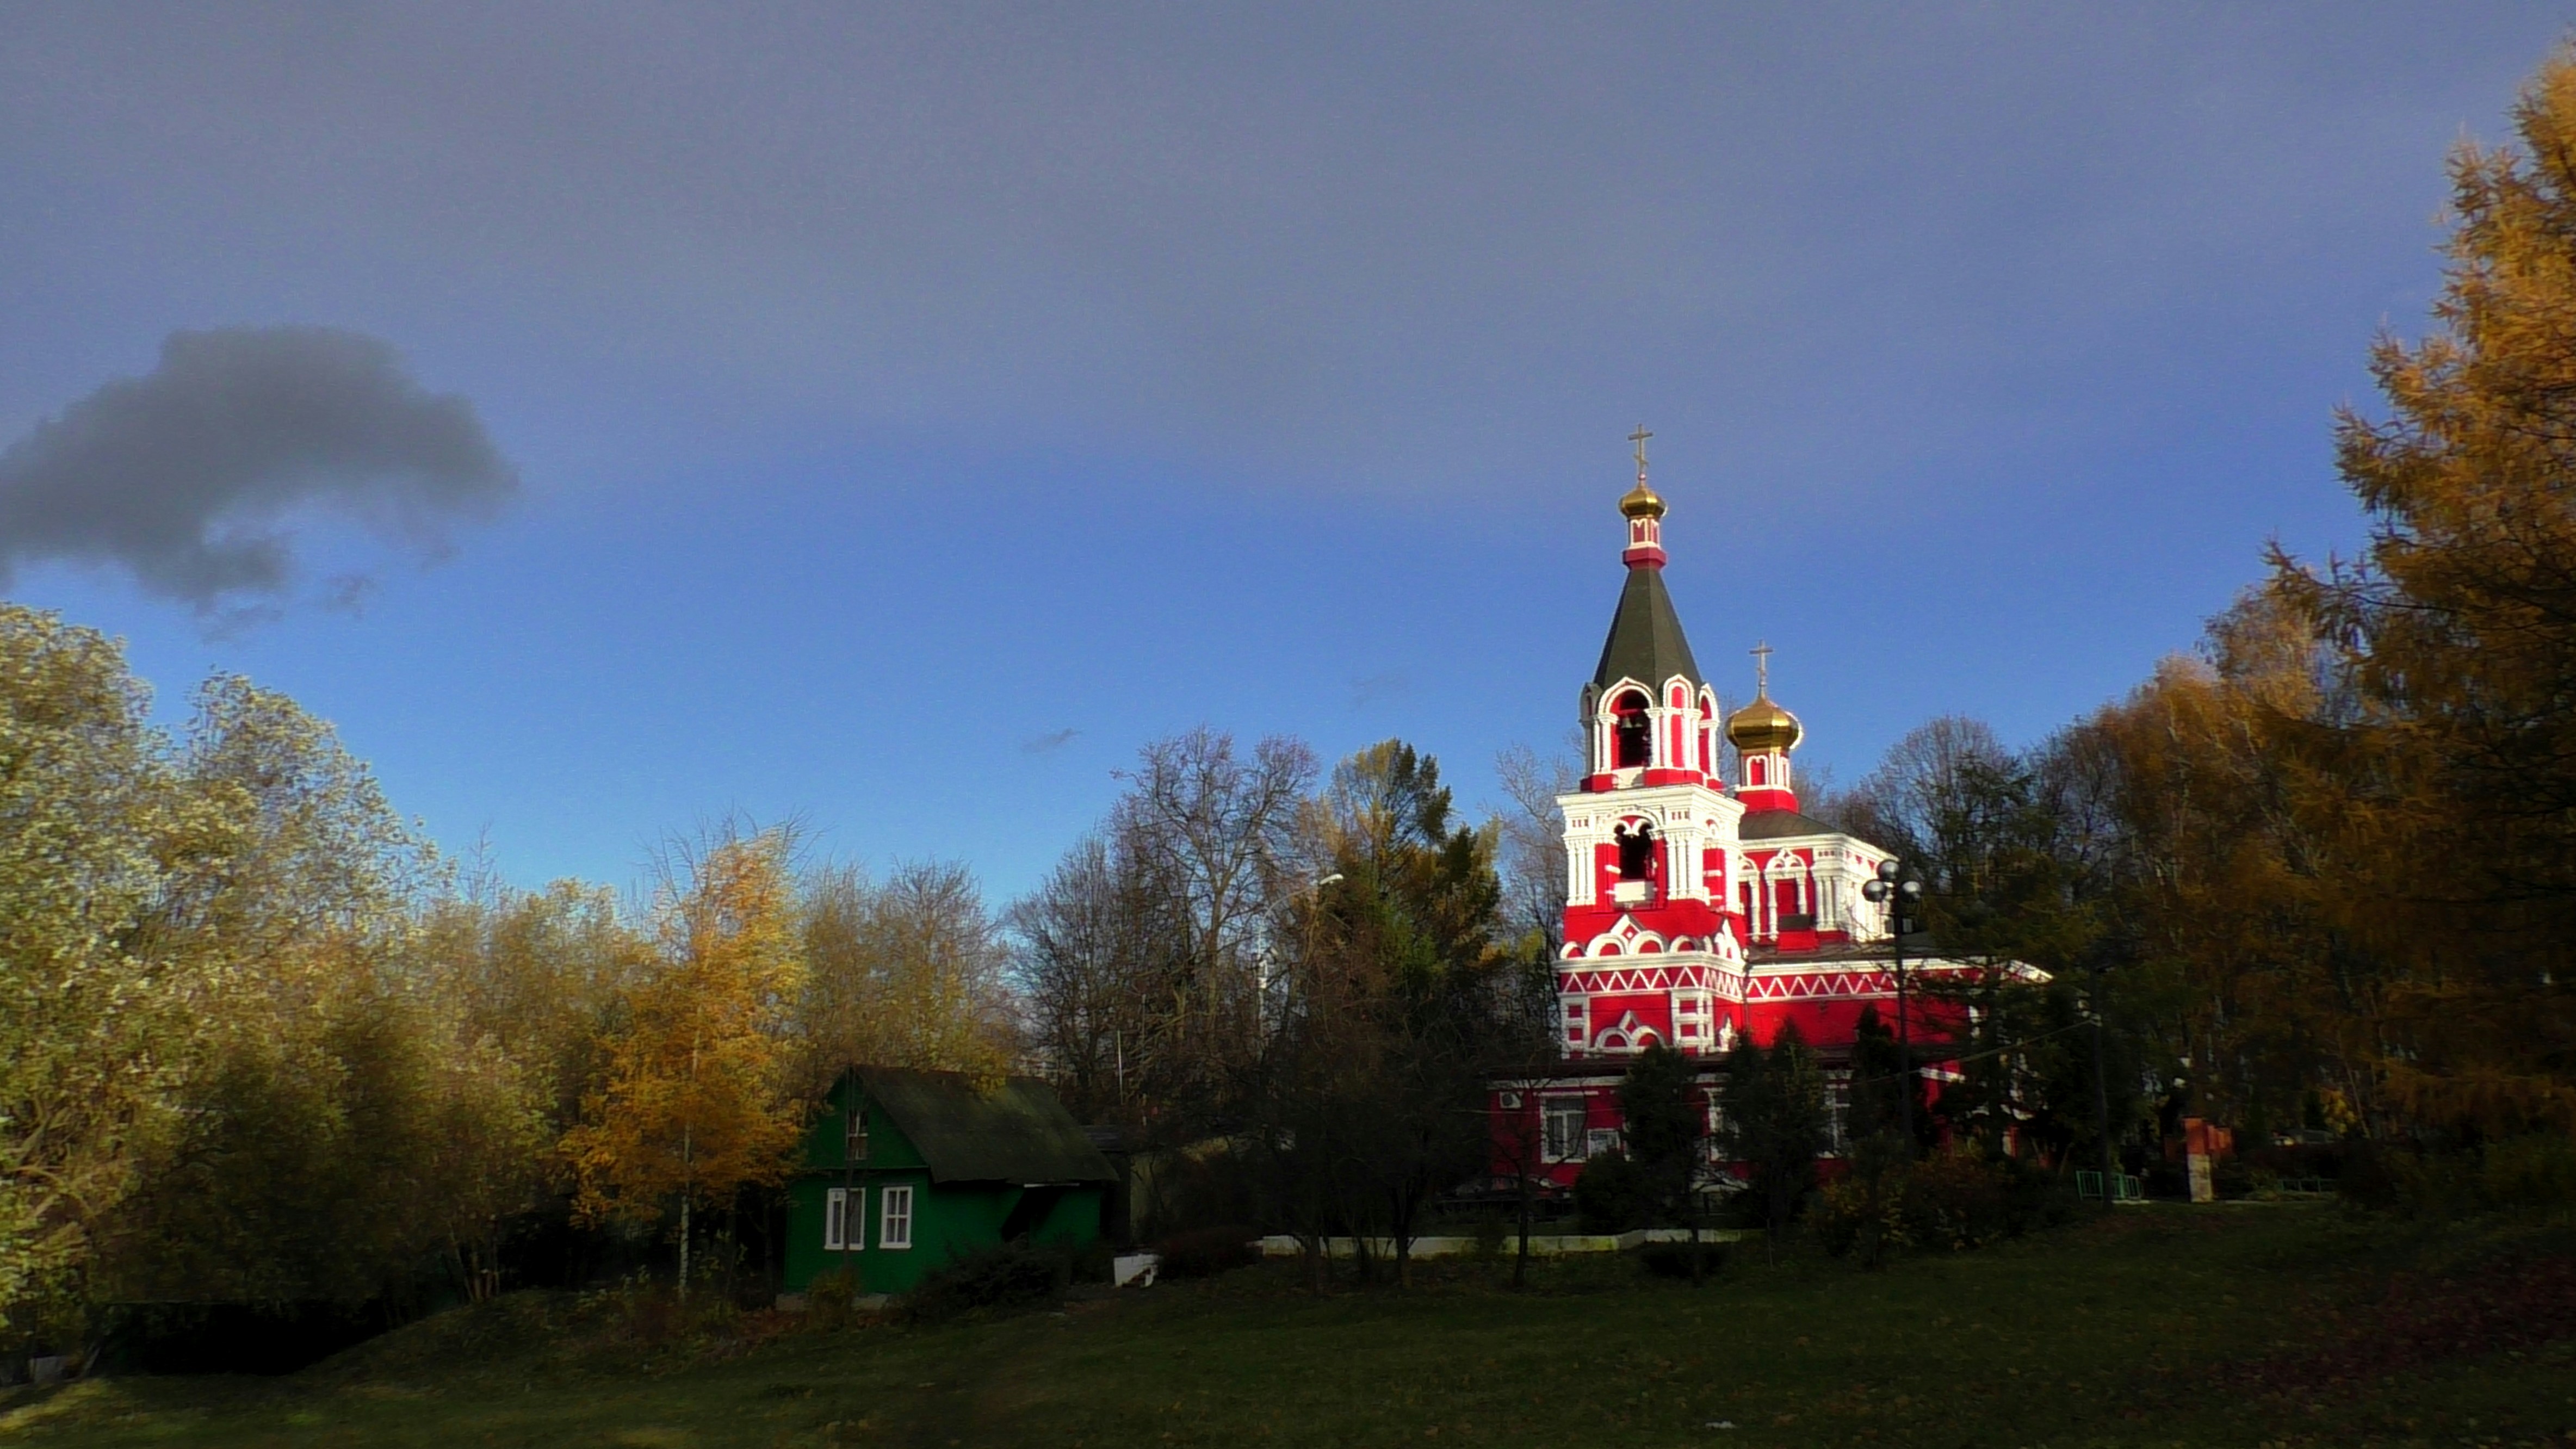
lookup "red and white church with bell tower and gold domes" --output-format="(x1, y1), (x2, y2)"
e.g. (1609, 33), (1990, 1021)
(1494, 433), (1973, 1186)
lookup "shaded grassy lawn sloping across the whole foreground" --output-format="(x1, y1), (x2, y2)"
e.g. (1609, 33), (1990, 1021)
(0, 1206), (2576, 1449)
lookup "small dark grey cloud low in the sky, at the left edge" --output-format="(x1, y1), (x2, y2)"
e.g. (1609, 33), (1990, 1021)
(0, 327), (518, 608)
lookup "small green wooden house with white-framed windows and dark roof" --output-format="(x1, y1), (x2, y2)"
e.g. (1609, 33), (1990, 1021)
(785, 1067), (1118, 1295)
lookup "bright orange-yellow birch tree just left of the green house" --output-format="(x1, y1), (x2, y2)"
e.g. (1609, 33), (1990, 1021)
(564, 830), (804, 1297)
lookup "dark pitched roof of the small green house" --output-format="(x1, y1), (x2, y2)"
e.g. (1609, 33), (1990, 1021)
(858, 1067), (1118, 1184)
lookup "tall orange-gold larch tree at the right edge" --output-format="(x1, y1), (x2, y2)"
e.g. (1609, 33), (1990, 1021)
(2272, 52), (2576, 1132)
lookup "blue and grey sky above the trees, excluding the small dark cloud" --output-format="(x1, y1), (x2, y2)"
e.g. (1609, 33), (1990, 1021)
(0, 3), (2568, 897)
